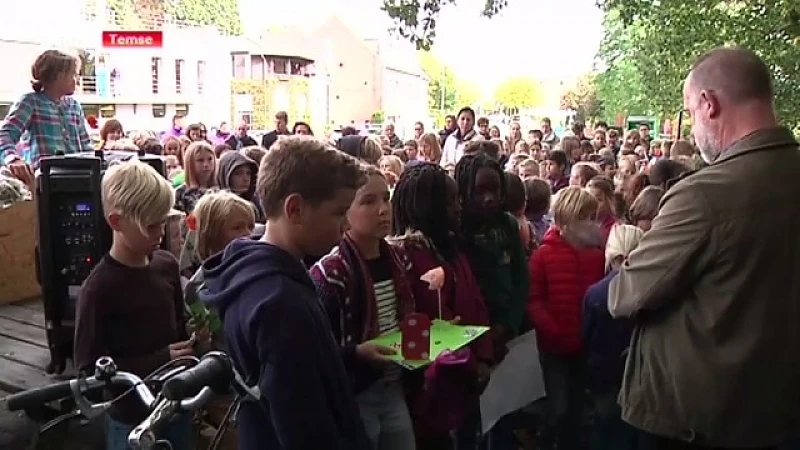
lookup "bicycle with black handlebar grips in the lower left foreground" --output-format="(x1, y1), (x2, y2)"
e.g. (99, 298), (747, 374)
(7, 351), (236, 450)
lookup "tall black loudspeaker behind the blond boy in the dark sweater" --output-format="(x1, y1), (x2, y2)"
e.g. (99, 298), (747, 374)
(36, 152), (167, 373)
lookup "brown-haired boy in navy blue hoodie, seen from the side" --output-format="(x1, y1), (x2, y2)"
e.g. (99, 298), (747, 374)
(199, 137), (369, 450)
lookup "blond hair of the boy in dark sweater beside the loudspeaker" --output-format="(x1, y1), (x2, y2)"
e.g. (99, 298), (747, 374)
(101, 160), (175, 234)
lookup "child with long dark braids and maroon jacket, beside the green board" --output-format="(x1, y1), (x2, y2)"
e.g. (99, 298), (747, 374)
(390, 162), (494, 450)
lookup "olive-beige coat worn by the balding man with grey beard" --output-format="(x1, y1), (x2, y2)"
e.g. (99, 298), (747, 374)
(608, 128), (800, 448)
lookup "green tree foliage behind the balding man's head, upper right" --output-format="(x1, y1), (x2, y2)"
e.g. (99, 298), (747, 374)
(598, 0), (800, 127)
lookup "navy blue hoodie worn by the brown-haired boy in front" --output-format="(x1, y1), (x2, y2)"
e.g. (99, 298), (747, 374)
(199, 239), (376, 450)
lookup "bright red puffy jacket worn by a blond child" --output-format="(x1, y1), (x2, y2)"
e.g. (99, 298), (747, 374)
(528, 227), (605, 355)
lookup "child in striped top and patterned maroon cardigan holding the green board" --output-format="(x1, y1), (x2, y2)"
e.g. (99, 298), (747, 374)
(310, 166), (415, 450)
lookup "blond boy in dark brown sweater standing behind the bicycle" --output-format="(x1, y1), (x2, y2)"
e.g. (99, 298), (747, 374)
(74, 160), (192, 450)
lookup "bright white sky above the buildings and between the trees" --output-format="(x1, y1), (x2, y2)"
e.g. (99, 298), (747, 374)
(240, 0), (603, 88)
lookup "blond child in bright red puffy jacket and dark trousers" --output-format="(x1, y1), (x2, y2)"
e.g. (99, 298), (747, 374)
(528, 186), (605, 450)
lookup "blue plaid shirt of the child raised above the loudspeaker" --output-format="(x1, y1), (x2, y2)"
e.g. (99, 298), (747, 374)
(0, 92), (93, 166)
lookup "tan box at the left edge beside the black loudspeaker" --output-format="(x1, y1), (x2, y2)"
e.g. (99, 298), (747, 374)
(0, 200), (42, 305)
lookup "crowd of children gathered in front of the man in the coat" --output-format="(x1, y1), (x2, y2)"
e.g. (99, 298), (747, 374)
(0, 48), (792, 450)
